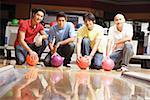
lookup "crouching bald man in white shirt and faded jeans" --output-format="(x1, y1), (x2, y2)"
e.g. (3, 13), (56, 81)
(106, 14), (133, 71)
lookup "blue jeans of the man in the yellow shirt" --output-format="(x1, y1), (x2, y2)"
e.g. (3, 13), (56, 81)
(81, 38), (103, 69)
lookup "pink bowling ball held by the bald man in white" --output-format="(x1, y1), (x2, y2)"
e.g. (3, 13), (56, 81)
(102, 57), (115, 71)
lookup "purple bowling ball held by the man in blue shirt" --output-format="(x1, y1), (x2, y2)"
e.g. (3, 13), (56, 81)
(51, 54), (64, 67)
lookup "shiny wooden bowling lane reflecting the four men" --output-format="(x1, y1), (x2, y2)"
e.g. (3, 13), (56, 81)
(0, 67), (150, 100)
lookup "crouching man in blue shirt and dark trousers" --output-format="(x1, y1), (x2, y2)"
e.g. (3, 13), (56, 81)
(44, 12), (75, 67)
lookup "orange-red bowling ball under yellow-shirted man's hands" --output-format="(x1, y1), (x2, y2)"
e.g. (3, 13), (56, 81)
(76, 57), (90, 69)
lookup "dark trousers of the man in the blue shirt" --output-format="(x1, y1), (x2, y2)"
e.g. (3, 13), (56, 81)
(44, 42), (75, 66)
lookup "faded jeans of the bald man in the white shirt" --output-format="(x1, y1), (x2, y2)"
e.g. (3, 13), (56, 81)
(110, 42), (134, 69)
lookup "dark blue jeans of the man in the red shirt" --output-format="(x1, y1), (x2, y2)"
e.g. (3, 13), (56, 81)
(15, 40), (47, 65)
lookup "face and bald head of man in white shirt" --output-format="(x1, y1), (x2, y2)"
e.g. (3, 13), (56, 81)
(114, 14), (125, 29)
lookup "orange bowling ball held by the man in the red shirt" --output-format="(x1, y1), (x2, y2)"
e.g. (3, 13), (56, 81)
(26, 54), (39, 66)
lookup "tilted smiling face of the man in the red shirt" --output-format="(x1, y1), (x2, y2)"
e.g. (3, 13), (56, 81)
(33, 11), (44, 23)
